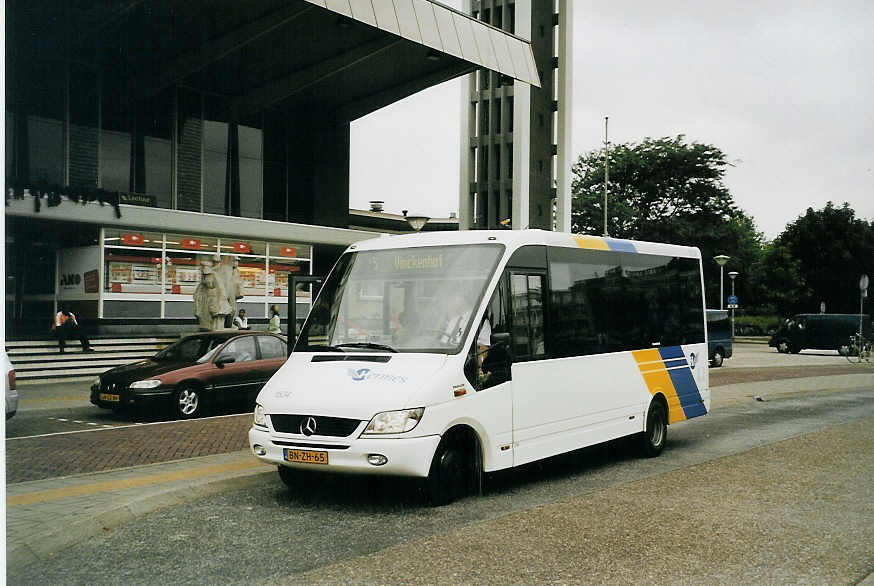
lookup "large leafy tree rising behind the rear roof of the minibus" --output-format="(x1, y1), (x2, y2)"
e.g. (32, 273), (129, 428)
(572, 135), (763, 307)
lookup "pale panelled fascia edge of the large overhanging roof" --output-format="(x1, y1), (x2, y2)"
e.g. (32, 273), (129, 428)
(305, 0), (540, 87)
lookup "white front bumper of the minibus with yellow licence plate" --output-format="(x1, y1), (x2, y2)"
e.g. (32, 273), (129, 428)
(249, 426), (440, 478)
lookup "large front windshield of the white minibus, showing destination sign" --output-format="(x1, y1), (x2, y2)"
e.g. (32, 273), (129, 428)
(295, 244), (504, 354)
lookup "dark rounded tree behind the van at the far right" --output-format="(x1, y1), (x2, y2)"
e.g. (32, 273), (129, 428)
(775, 202), (874, 313)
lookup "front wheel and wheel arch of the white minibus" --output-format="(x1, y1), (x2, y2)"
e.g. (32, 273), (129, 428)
(425, 425), (483, 507)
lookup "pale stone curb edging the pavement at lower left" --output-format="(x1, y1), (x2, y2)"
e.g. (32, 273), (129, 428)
(6, 458), (275, 570)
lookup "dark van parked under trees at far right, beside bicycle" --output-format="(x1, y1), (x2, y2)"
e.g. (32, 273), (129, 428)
(768, 313), (871, 354)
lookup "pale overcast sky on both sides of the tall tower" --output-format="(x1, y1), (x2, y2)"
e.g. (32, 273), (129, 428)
(350, 0), (874, 239)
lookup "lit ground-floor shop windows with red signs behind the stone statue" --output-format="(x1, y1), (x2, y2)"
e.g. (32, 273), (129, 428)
(101, 228), (312, 318)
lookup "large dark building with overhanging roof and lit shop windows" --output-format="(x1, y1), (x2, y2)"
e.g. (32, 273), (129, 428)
(5, 0), (540, 334)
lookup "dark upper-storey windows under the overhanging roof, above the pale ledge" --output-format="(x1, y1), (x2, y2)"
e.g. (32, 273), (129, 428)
(6, 59), (276, 220)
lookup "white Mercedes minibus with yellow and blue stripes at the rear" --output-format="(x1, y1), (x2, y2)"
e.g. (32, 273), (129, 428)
(249, 230), (710, 504)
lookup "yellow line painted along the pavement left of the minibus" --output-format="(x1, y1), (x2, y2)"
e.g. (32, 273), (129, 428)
(6, 458), (267, 507)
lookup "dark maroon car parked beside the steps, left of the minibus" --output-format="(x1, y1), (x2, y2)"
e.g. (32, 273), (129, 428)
(91, 330), (286, 419)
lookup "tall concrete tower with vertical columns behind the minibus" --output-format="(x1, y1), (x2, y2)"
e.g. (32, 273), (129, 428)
(459, 0), (573, 231)
